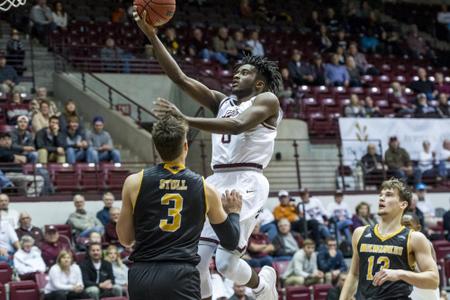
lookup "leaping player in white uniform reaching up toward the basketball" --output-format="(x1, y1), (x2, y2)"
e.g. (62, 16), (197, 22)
(134, 8), (282, 300)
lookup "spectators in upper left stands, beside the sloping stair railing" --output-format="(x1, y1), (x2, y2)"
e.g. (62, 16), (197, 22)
(0, 64), (121, 196)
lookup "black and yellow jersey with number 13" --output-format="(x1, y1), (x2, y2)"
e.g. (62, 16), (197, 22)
(356, 224), (414, 300)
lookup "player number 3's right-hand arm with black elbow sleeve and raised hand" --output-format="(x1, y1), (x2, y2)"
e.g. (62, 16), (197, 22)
(205, 183), (242, 251)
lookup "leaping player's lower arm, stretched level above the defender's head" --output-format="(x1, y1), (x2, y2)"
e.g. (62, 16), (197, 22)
(153, 92), (280, 134)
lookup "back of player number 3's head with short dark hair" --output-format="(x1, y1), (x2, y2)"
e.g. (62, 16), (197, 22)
(152, 114), (189, 161)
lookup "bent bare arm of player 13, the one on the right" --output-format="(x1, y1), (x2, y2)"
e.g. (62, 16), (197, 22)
(373, 231), (439, 290)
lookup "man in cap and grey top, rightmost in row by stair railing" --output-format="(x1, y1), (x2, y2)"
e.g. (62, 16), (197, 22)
(88, 116), (120, 164)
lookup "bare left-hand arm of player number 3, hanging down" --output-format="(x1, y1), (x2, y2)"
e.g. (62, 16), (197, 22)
(116, 172), (142, 247)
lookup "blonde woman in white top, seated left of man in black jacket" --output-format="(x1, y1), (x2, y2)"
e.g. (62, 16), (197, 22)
(45, 250), (89, 300)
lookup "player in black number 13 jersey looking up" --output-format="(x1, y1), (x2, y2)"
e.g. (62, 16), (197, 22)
(339, 179), (439, 300)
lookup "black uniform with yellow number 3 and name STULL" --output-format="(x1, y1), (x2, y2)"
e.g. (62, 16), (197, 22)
(128, 164), (207, 300)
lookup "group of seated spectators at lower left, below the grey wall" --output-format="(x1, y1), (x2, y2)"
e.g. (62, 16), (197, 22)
(0, 192), (130, 300)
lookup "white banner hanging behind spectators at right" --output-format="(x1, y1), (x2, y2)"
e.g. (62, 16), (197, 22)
(339, 118), (450, 165)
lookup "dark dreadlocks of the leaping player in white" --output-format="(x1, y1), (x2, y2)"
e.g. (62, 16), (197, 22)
(235, 55), (282, 94)
